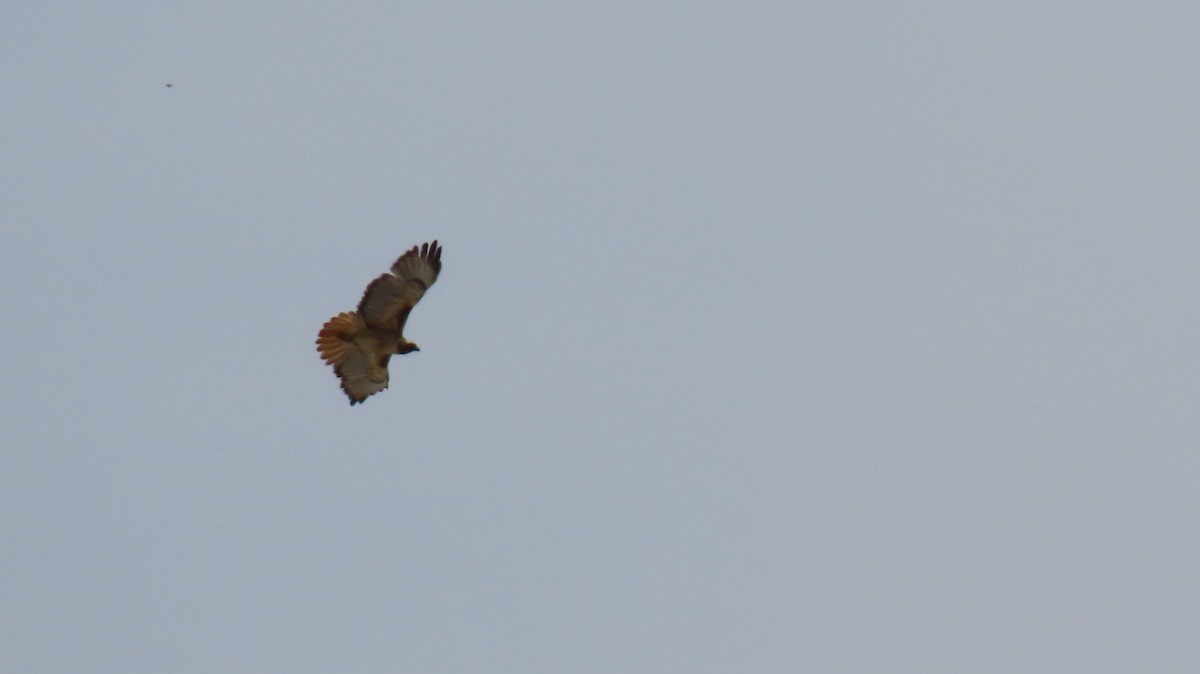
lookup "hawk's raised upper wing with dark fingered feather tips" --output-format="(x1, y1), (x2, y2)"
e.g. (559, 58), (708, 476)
(359, 241), (442, 332)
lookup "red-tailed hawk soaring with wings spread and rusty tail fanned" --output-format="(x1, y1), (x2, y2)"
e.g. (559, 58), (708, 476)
(317, 241), (442, 405)
